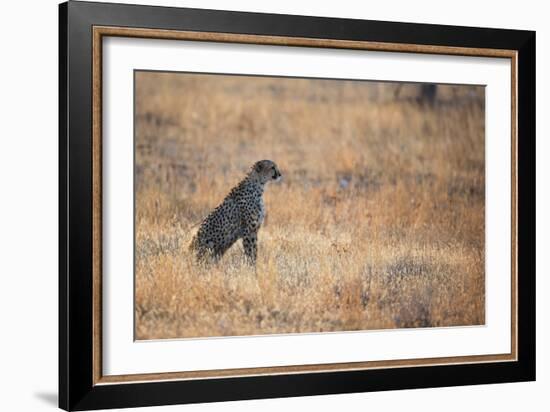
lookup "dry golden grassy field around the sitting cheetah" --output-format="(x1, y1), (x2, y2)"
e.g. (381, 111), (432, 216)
(135, 72), (485, 339)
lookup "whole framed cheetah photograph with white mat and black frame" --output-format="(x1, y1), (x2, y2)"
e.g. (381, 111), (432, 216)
(59, 1), (535, 410)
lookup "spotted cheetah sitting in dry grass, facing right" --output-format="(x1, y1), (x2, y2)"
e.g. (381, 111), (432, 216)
(190, 160), (281, 265)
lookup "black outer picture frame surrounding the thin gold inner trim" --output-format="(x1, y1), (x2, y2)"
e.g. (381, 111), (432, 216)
(59, 1), (535, 410)
